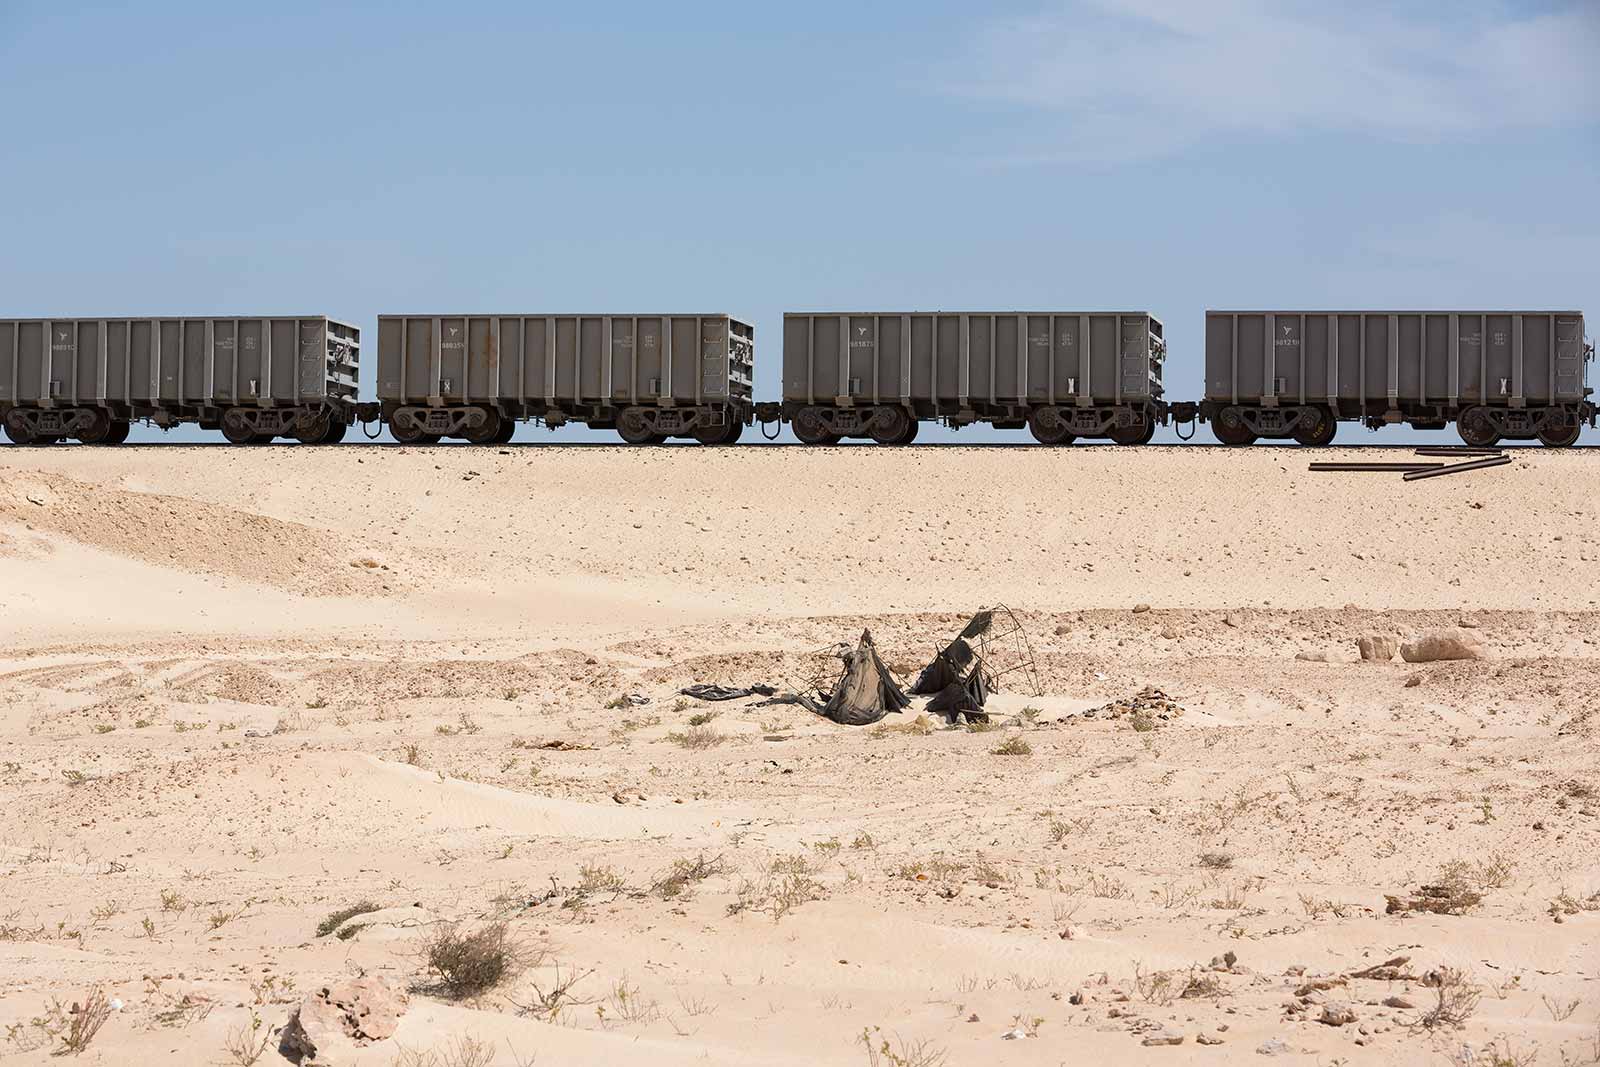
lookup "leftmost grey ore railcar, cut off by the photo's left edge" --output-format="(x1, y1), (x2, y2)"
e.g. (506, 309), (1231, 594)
(0, 315), (360, 445)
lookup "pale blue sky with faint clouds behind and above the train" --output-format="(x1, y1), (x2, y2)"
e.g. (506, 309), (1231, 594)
(0, 0), (1600, 442)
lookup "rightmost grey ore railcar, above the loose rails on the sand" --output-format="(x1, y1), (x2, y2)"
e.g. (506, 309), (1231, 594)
(1200, 310), (1595, 446)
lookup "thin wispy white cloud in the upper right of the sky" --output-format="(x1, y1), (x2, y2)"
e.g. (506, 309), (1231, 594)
(962, 0), (1600, 152)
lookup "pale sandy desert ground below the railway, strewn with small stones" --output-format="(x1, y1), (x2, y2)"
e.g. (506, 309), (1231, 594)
(0, 446), (1600, 1067)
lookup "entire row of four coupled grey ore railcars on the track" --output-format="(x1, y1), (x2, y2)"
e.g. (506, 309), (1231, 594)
(0, 310), (1597, 446)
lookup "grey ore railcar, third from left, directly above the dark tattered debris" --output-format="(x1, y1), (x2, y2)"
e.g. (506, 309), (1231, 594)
(762, 312), (1168, 445)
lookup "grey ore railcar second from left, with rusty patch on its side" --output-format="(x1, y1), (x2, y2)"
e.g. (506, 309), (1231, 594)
(378, 314), (755, 445)
